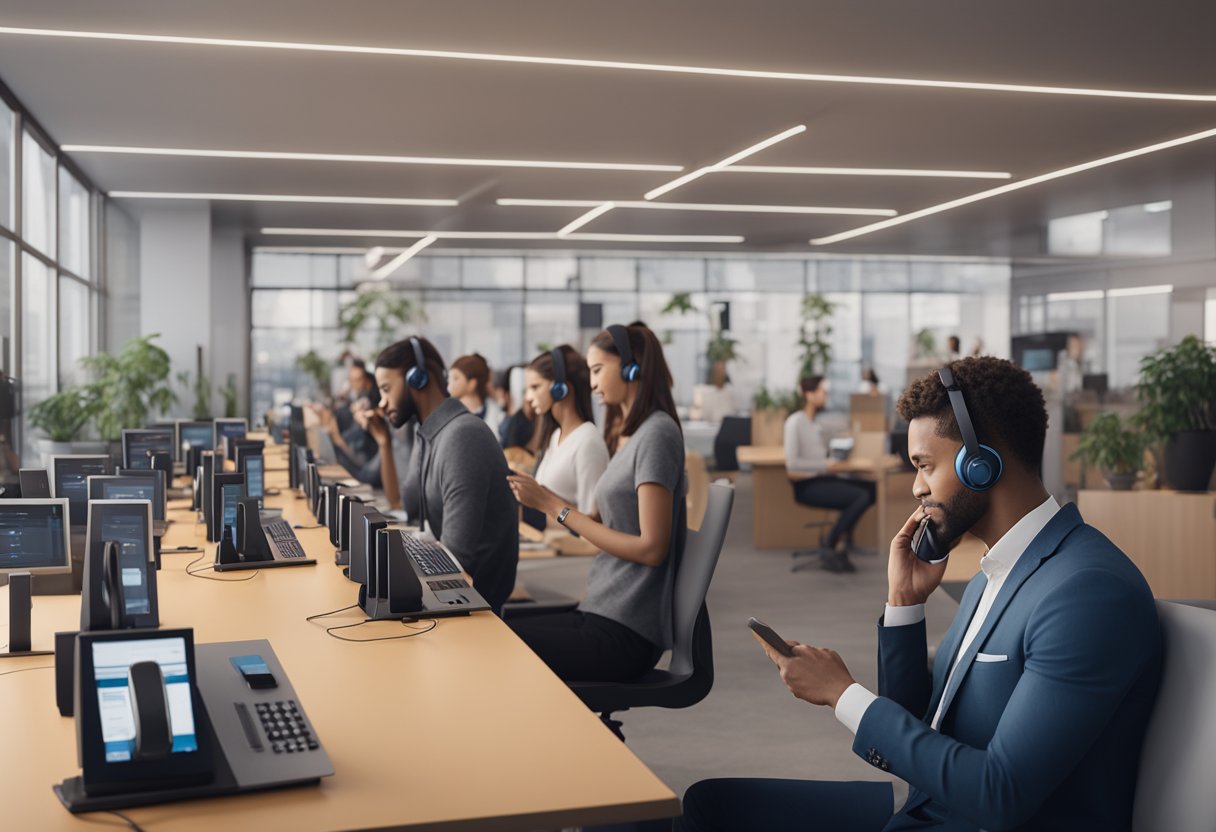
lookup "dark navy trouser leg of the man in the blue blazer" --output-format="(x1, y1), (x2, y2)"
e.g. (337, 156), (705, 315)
(675, 778), (895, 832)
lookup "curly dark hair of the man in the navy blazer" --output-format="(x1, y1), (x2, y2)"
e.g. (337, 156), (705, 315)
(896, 356), (1047, 473)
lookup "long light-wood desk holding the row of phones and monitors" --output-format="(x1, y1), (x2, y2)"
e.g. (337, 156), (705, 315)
(0, 449), (680, 832)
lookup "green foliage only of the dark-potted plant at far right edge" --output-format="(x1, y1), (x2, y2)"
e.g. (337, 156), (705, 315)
(1136, 335), (1216, 440)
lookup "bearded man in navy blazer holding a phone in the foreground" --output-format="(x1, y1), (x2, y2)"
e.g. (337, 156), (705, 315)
(682, 358), (1161, 832)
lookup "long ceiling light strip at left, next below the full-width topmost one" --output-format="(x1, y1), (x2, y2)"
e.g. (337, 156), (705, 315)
(60, 145), (683, 173)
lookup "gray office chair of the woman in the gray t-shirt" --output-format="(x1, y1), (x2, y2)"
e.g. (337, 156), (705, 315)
(570, 483), (734, 742)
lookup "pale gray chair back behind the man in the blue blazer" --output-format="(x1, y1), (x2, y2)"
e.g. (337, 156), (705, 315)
(1132, 601), (1216, 832)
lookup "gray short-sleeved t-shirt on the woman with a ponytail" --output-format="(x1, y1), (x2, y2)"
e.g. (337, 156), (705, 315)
(579, 411), (688, 650)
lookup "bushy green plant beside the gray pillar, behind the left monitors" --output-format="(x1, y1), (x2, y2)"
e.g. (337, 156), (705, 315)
(80, 333), (178, 442)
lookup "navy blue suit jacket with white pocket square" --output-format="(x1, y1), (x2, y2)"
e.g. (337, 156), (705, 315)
(854, 504), (1161, 832)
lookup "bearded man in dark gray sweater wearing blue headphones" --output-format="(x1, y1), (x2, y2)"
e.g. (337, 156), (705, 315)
(376, 337), (519, 613)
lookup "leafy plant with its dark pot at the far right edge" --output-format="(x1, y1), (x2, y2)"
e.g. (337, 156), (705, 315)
(1136, 335), (1216, 491)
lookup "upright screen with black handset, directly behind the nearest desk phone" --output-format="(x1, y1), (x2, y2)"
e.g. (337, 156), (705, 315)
(80, 500), (161, 630)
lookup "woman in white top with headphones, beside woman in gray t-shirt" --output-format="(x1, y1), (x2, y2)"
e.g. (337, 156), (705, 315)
(524, 344), (608, 516)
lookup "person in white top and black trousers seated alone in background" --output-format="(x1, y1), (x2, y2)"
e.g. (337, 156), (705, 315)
(784, 376), (876, 572)
